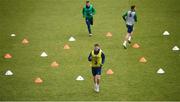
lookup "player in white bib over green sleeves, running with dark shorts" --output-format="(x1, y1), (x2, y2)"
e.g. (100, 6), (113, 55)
(122, 5), (137, 49)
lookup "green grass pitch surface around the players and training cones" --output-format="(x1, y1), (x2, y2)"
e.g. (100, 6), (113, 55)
(0, 0), (180, 101)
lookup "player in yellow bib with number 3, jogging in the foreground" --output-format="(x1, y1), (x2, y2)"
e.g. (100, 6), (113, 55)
(88, 44), (105, 92)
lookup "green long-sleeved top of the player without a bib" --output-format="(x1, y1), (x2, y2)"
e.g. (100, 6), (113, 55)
(82, 5), (96, 18)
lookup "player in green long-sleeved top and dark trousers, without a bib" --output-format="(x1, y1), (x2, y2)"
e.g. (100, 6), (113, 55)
(82, 1), (96, 36)
